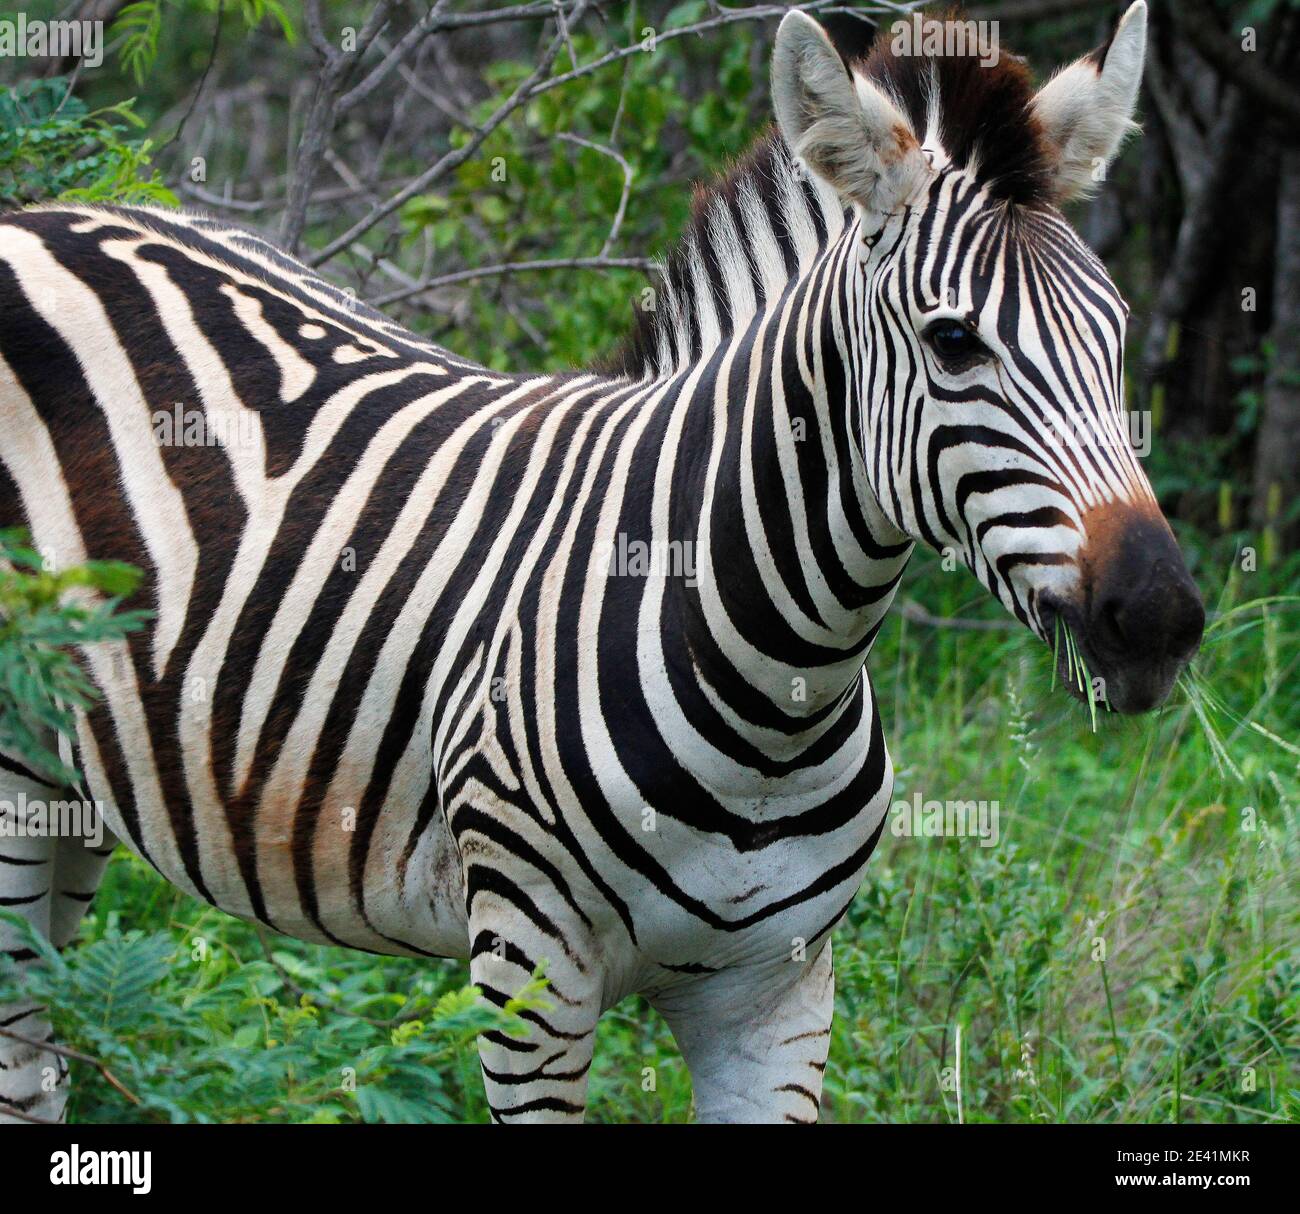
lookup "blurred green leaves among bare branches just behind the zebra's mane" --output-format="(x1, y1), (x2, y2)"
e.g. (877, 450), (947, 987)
(390, 15), (763, 370)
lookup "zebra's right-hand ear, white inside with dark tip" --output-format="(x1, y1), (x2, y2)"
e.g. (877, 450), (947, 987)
(1034, 0), (1147, 201)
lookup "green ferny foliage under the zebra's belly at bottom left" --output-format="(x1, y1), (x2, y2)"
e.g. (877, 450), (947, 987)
(0, 857), (550, 1123)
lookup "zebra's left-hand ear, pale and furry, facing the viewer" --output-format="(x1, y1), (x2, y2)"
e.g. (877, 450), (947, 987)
(772, 10), (928, 216)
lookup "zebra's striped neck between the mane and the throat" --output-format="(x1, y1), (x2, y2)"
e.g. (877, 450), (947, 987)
(677, 234), (911, 760)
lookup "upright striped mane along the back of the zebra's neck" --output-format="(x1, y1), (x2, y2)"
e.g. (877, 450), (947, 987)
(602, 127), (846, 378)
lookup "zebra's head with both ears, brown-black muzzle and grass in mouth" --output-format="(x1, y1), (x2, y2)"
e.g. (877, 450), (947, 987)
(772, 0), (1204, 712)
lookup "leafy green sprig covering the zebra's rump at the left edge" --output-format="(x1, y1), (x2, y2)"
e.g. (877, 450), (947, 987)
(0, 530), (151, 781)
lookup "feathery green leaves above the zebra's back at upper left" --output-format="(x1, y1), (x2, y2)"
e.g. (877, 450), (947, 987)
(0, 77), (177, 207)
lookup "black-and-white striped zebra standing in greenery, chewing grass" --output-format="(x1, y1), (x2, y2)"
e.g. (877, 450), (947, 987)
(0, 0), (1204, 1122)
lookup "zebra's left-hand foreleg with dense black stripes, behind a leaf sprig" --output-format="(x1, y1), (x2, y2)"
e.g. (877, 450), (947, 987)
(469, 883), (602, 1124)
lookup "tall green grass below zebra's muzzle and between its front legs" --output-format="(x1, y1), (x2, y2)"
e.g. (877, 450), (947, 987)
(593, 543), (1300, 1123)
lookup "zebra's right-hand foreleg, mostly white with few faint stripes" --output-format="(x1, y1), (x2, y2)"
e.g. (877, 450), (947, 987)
(651, 940), (835, 1122)
